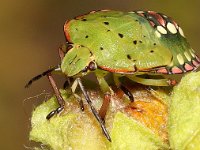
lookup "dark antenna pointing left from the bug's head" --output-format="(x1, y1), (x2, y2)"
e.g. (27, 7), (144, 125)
(25, 65), (60, 88)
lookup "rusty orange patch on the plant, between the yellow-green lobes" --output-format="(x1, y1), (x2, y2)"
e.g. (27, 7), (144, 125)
(125, 96), (168, 141)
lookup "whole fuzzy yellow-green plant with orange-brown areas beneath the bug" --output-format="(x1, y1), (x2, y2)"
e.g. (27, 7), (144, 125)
(29, 72), (200, 150)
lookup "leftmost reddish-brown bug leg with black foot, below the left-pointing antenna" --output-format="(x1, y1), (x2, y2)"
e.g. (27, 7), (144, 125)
(46, 73), (65, 120)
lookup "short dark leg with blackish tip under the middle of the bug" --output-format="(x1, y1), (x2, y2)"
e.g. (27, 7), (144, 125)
(113, 74), (134, 102)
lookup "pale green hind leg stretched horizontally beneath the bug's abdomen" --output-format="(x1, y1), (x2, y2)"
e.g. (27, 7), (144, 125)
(126, 75), (176, 86)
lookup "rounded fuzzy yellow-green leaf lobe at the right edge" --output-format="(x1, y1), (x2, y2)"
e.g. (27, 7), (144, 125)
(168, 72), (200, 150)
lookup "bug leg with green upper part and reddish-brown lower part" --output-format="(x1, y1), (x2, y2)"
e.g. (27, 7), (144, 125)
(95, 72), (114, 119)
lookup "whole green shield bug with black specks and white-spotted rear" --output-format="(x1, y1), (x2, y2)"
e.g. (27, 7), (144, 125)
(26, 10), (200, 141)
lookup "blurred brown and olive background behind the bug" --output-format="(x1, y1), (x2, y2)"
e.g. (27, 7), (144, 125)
(0, 0), (200, 150)
